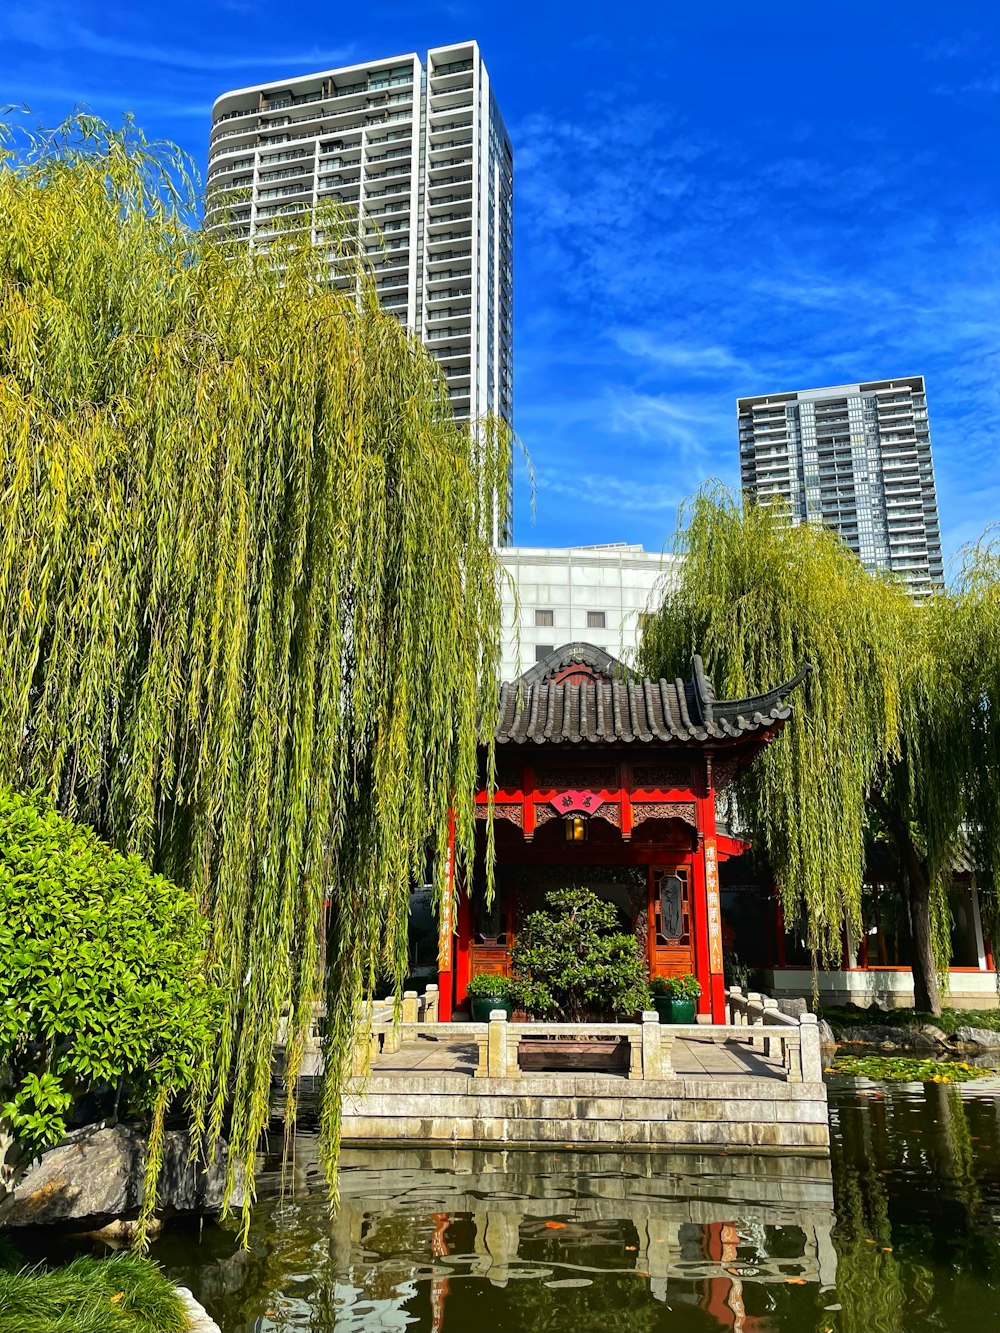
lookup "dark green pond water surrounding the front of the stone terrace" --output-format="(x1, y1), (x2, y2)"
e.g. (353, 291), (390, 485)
(144, 1078), (1000, 1333)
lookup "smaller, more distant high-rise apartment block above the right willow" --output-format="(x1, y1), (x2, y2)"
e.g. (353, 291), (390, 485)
(736, 375), (944, 597)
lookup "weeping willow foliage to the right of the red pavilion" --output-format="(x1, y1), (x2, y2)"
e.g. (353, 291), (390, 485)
(640, 487), (1000, 1013)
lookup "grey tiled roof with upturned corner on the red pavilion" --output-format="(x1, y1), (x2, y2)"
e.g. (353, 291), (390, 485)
(496, 644), (812, 745)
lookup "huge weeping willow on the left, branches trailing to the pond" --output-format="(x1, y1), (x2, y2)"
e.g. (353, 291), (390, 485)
(0, 117), (509, 1226)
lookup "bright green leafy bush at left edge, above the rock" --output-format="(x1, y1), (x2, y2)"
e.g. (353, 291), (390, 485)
(0, 786), (217, 1156)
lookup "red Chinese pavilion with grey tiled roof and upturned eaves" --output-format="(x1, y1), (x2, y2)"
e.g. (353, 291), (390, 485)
(437, 644), (809, 1022)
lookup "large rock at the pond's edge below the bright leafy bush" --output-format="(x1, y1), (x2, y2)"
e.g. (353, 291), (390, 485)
(0, 1125), (243, 1226)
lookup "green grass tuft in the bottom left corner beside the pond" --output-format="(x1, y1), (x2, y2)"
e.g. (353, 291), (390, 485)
(0, 1254), (191, 1333)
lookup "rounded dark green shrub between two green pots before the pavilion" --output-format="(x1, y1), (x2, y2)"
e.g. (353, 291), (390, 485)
(512, 888), (647, 1022)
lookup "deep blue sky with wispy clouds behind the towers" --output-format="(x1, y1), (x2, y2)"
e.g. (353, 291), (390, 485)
(0, 0), (1000, 556)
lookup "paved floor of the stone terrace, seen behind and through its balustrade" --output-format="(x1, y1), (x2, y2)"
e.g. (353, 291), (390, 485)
(373, 1025), (785, 1092)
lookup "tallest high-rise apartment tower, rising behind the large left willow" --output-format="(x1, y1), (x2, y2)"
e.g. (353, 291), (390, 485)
(207, 41), (513, 424)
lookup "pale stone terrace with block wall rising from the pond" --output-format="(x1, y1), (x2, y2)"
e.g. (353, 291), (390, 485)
(341, 1022), (829, 1157)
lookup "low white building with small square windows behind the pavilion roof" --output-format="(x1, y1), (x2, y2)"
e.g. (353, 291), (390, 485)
(500, 543), (675, 680)
